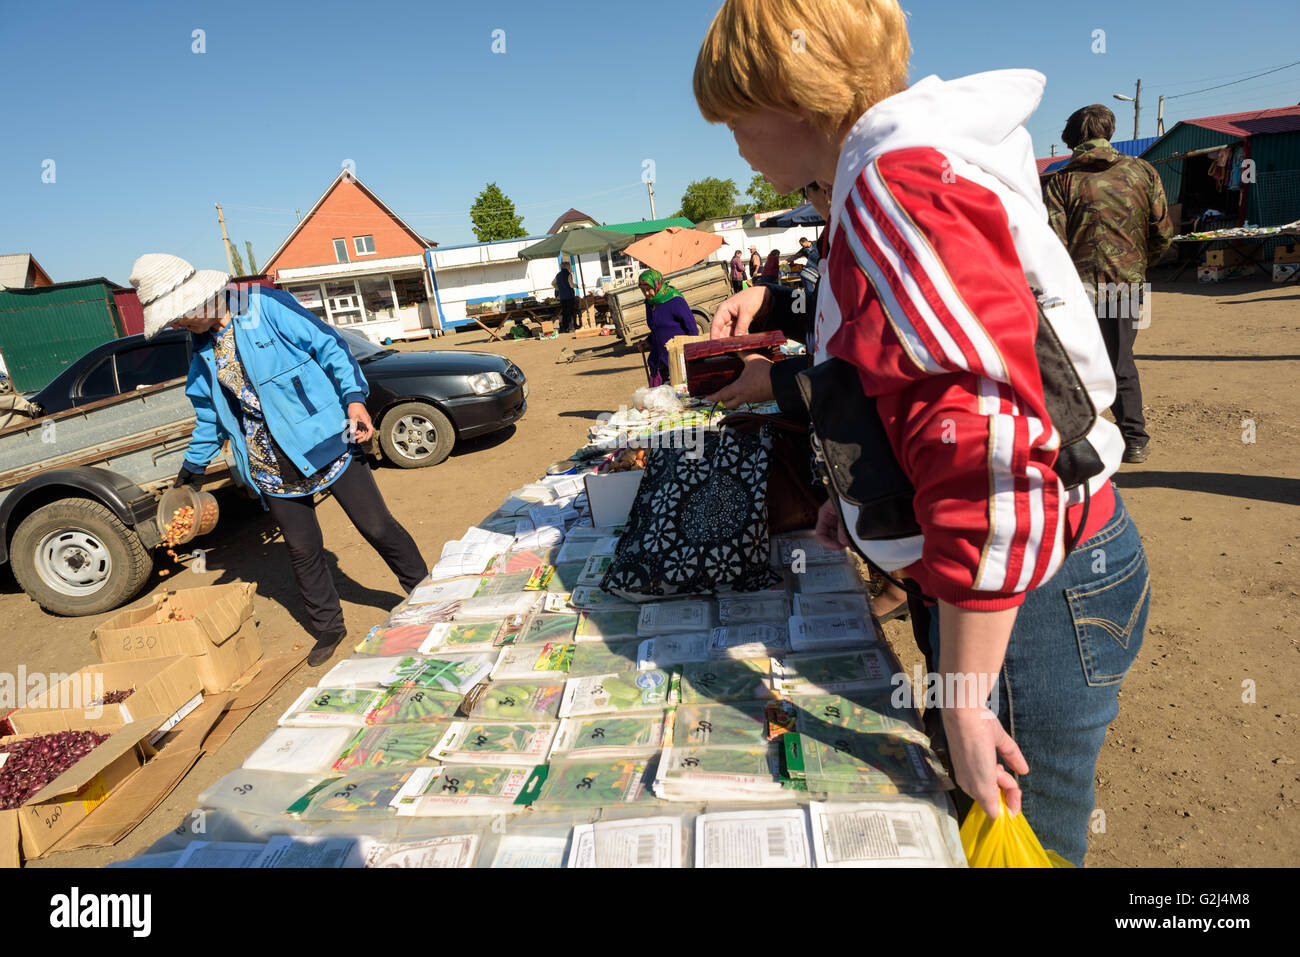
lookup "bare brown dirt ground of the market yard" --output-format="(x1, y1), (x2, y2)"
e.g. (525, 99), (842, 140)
(10, 282), (1300, 867)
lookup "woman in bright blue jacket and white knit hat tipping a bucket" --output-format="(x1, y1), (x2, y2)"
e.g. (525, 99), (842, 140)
(131, 254), (426, 666)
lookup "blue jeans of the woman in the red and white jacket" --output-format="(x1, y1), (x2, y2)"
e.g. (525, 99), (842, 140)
(930, 490), (1151, 867)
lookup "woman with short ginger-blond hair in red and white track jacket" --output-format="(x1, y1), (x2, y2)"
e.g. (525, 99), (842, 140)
(694, 0), (1151, 863)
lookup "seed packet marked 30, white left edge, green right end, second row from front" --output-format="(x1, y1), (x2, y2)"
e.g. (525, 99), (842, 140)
(391, 765), (545, 818)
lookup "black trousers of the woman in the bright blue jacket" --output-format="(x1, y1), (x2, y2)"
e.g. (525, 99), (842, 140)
(267, 455), (428, 638)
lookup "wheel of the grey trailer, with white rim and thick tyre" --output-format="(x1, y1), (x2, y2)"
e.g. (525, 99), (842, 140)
(9, 498), (153, 616)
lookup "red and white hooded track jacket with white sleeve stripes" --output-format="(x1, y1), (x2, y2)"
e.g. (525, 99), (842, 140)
(815, 70), (1123, 610)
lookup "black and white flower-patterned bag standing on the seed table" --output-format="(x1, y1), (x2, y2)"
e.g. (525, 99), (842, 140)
(601, 426), (777, 601)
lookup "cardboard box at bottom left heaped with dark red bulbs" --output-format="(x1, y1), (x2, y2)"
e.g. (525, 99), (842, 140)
(0, 715), (164, 858)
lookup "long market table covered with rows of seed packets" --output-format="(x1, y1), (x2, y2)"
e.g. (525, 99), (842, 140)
(111, 387), (965, 867)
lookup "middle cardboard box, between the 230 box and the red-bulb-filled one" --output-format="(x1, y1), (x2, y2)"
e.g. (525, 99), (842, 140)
(9, 655), (202, 740)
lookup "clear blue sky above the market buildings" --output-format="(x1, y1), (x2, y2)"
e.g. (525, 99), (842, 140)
(0, 0), (1300, 283)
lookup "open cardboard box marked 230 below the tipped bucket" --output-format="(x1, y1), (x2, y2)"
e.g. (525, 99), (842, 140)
(91, 581), (261, 694)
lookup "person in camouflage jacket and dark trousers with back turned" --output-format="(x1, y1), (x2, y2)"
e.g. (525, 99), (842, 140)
(1043, 105), (1174, 462)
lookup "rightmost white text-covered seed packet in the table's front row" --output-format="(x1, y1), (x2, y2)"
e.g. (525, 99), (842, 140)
(809, 801), (952, 867)
